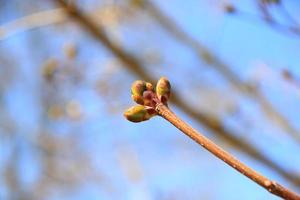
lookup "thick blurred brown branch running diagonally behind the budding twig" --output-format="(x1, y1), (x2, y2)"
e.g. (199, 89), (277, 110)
(55, 0), (300, 188)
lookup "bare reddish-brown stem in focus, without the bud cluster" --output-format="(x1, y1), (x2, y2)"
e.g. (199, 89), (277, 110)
(155, 103), (300, 200)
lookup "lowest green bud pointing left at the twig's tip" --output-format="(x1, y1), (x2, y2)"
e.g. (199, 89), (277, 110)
(124, 105), (155, 122)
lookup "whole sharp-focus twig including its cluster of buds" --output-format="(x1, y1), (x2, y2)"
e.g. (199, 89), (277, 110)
(124, 77), (300, 200)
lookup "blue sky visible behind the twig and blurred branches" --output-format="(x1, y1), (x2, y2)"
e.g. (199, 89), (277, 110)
(0, 0), (300, 200)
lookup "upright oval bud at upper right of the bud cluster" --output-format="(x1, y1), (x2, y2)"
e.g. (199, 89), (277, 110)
(156, 77), (171, 104)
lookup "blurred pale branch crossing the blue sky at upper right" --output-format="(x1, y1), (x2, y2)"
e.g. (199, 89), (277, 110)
(140, 0), (300, 143)
